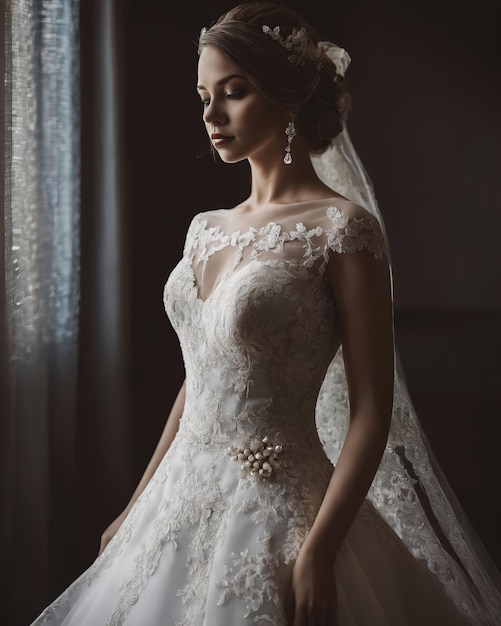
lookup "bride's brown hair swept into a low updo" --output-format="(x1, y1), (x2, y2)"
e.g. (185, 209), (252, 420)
(198, 2), (350, 152)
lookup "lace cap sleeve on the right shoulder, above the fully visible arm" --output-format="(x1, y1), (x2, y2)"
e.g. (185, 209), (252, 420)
(326, 207), (388, 259)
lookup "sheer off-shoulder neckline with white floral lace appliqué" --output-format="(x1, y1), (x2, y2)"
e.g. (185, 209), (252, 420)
(185, 204), (384, 302)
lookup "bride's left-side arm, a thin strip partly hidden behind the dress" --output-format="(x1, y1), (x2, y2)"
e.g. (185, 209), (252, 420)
(99, 381), (186, 554)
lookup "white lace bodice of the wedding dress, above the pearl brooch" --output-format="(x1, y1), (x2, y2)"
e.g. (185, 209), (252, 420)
(165, 202), (385, 462)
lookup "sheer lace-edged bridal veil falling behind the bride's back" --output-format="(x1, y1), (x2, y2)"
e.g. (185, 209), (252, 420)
(312, 42), (501, 625)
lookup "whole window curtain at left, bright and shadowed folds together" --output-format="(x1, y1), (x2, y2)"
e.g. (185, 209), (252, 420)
(0, 0), (130, 626)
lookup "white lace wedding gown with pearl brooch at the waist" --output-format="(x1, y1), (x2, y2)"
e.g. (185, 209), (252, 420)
(30, 199), (501, 626)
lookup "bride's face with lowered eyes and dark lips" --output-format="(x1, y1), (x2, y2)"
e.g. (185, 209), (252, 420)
(197, 46), (288, 163)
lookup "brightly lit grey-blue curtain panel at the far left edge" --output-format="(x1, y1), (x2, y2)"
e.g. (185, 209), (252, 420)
(1, 0), (80, 616)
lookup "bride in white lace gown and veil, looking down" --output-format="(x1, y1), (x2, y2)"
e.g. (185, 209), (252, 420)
(34, 3), (500, 626)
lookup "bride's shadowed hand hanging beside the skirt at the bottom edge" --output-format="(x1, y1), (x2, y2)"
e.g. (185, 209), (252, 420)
(288, 544), (338, 626)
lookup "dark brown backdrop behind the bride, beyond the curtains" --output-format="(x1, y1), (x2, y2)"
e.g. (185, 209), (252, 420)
(22, 0), (501, 614)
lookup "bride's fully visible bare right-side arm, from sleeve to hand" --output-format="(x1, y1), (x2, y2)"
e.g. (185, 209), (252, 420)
(290, 251), (394, 626)
